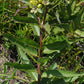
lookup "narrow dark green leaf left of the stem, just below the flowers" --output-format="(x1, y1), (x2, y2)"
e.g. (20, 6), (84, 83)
(13, 16), (38, 24)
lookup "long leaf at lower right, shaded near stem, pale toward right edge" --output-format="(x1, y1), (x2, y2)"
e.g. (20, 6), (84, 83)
(42, 70), (84, 78)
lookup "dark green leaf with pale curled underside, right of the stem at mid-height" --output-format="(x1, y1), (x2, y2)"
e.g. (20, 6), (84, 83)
(43, 41), (68, 54)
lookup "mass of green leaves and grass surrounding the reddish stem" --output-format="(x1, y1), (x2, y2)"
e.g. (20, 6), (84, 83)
(0, 0), (84, 84)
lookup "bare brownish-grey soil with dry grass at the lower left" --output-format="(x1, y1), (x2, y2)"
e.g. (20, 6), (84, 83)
(0, 36), (28, 84)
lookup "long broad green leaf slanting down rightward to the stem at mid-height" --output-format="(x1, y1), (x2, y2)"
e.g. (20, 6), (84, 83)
(3, 34), (38, 56)
